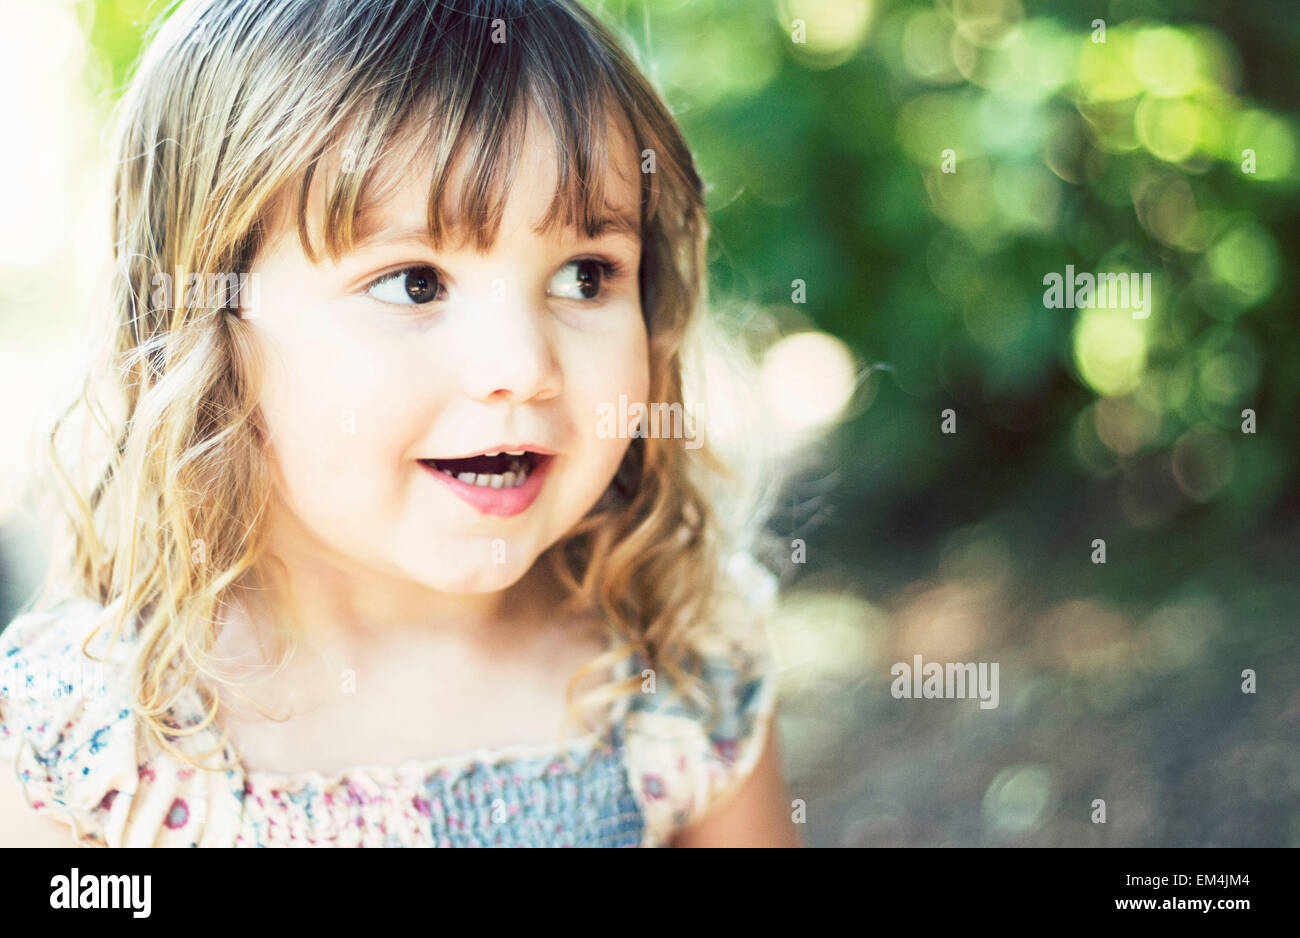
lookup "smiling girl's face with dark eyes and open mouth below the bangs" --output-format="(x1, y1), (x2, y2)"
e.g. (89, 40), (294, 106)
(248, 113), (649, 592)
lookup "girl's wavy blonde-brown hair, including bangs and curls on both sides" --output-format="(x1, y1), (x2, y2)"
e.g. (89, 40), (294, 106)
(32, 0), (780, 761)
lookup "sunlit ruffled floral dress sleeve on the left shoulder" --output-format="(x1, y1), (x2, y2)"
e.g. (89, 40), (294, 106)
(0, 600), (243, 847)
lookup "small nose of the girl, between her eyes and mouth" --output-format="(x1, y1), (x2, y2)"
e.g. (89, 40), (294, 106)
(460, 288), (562, 403)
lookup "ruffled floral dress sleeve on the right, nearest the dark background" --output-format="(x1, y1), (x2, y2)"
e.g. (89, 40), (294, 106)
(624, 556), (776, 846)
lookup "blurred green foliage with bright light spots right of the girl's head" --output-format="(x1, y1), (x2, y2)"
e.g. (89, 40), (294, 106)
(603, 0), (1300, 610)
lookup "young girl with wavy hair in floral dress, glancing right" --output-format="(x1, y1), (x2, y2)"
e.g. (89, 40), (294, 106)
(0, 0), (800, 846)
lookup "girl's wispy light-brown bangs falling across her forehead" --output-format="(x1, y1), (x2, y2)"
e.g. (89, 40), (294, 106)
(278, 0), (663, 262)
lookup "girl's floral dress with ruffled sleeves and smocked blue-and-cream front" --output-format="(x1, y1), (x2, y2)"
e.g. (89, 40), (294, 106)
(0, 550), (775, 847)
